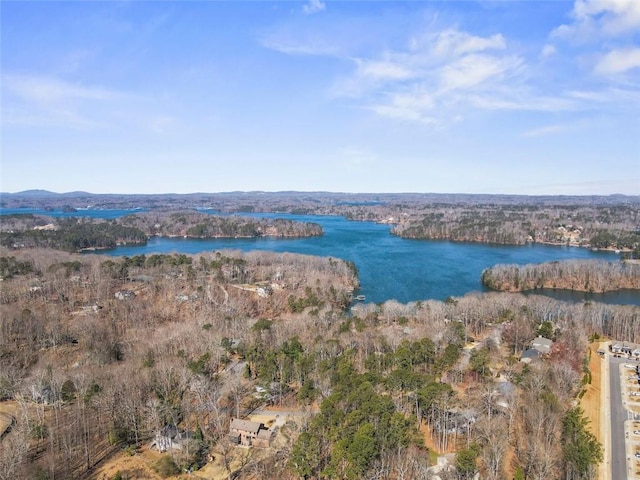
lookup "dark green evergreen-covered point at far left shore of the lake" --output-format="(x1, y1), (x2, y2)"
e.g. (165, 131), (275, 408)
(0, 218), (147, 252)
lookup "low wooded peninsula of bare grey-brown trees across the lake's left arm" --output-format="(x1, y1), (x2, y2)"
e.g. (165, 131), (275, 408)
(118, 211), (322, 238)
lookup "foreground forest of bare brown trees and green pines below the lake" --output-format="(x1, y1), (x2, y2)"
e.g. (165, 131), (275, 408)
(0, 244), (640, 480)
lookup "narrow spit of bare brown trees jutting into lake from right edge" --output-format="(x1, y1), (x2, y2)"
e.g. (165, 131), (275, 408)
(482, 260), (640, 292)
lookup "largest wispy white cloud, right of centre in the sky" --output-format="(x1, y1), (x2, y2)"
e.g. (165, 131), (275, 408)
(332, 28), (536, 127)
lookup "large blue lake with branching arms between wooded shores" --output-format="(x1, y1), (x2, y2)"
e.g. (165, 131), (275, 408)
(0, 209), (640, 305)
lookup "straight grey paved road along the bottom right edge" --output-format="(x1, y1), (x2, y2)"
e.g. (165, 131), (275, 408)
(608, 355), (631, 480)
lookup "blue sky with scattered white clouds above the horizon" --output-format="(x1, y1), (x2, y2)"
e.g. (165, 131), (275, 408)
(0, 0), (640, 195)
